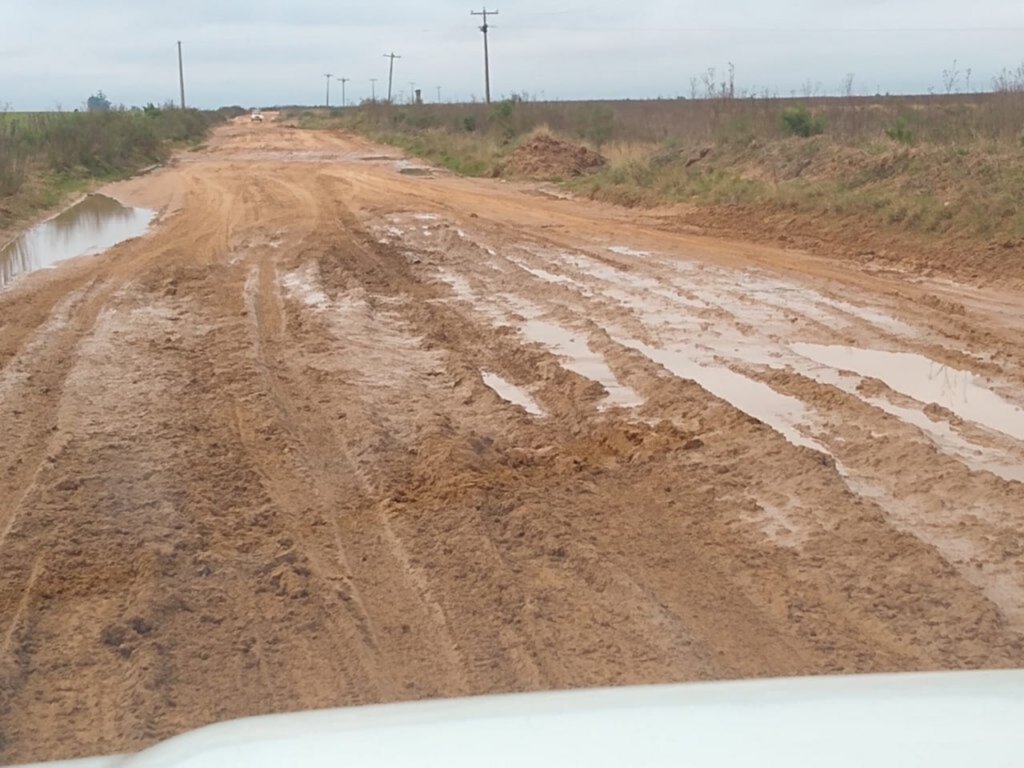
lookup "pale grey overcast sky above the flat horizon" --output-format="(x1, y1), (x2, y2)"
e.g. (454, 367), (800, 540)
(0, 0), (1024, 111)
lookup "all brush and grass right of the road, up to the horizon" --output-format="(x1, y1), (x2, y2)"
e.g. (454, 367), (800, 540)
(290, 81), (1024, 247)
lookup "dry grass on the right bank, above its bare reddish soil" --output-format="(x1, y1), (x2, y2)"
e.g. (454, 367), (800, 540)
(567, 139), (1024, 241)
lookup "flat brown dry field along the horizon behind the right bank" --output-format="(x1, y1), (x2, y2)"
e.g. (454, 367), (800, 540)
(292, 90), (1024, 145)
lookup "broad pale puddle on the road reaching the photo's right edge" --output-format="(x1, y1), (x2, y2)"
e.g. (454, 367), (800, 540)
(791, 344), (1024, 440)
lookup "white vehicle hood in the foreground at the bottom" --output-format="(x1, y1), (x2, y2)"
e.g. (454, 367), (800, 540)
(14, 670), (1024, 768)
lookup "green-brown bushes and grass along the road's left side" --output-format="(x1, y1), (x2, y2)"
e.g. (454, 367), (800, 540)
(0, 103), (244, 230)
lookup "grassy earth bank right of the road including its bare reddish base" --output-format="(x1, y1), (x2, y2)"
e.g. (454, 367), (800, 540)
(577, 137), (1024, 286)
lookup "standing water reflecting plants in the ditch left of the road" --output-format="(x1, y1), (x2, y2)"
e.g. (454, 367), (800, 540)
(0, 195), (156, 288)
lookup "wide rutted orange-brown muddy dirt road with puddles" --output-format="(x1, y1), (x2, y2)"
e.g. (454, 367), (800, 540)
(0, 118), (1024, 762)
